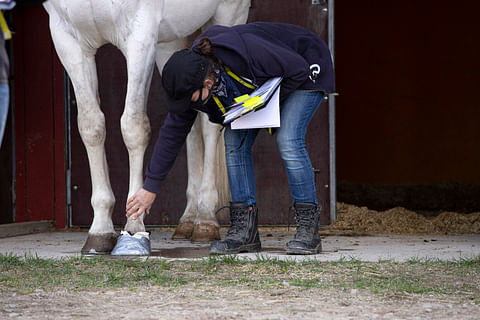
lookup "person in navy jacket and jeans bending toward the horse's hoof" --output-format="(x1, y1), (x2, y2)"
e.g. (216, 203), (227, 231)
(126, 22), (334, 254)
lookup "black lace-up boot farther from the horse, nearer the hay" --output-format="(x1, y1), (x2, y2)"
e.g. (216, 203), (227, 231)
(287, 202), (322, 254)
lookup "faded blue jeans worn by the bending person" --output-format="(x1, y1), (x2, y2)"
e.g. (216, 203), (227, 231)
(225, 90), (323, 205)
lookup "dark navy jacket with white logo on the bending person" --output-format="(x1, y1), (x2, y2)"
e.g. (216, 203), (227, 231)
(144, 22), (334, 193)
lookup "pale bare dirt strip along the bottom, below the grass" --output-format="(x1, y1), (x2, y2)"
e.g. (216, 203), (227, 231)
(0, 286), (479, 320)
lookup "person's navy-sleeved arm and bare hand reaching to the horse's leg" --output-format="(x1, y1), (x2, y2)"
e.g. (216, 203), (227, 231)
(126, 110), (197, 220)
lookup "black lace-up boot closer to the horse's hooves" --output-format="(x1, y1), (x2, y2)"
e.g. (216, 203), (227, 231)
(210, 202), (262, 254)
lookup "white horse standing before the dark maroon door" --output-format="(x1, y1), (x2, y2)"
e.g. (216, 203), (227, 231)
(44, 0), (250, 253)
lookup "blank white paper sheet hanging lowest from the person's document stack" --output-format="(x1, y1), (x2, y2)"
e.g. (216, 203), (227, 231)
(231, 86), (280, 130)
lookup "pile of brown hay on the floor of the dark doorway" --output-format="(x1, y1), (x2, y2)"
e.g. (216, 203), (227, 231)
(330, 203), (480, 234)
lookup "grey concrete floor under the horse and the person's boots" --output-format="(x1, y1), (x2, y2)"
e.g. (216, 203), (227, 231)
(0, 229), (480, 262)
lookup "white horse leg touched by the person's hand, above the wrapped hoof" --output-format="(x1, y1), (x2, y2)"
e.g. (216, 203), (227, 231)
(121, 31), (156, 233)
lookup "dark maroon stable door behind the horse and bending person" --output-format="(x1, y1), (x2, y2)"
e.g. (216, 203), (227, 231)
(67, 0), (334, 226)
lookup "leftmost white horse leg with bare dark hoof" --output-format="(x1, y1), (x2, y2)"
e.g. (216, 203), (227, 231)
(50, 20), (116, 253)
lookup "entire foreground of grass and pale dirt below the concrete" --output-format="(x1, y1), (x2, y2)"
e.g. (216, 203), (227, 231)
(0, 252), (480, 320)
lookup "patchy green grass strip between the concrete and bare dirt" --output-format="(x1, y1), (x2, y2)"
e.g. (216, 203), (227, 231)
(0, 254), (480, 303)
